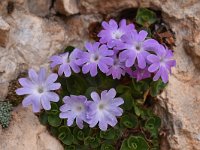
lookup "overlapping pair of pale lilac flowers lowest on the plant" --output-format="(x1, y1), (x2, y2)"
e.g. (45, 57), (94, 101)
(60, 89), (124, 131)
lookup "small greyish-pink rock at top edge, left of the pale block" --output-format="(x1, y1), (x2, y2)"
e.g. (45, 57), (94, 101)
(28, 0), (52, 17)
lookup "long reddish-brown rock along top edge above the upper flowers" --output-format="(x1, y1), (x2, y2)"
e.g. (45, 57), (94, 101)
(79, 0), (138, 14)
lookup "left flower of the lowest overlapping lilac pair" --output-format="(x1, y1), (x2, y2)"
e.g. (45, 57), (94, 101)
(59, 95), (87, 129)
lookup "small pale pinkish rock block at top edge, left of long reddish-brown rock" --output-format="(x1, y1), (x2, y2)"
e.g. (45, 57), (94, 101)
(55, 0), (79, 16)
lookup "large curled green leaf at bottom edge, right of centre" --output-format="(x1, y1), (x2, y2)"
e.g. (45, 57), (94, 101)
(127, 136), (149, 150)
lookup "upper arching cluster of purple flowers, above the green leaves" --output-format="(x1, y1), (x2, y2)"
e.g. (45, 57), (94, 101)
(51, 19), (176, 83)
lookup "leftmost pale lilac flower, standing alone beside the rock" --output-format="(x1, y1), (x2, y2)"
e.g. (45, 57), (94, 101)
(16, 68), (61, 112)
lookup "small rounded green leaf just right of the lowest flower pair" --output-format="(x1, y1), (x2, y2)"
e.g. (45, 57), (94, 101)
(120, 114), (138, 128)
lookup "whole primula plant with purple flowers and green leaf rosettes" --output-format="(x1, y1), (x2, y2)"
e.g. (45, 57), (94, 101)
(16, 10), (176, 150)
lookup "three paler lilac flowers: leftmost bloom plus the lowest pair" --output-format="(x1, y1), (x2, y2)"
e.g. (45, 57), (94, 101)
(16, 71), (124, 131)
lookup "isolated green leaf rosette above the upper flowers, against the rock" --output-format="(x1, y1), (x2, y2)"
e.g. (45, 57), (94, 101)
(136, 8), (157, 27)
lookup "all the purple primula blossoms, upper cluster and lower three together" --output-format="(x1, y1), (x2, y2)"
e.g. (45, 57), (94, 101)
(16, 19), (176, 131)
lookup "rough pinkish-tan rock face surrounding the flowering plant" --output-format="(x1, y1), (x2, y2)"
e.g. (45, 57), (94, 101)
(0, 0), (200, 150)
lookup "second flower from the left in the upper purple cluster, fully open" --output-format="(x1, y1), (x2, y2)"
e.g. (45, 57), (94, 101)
(76, 42), (113, 77)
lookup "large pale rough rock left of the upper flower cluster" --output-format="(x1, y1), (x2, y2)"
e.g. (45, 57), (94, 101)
(0, 11), (65, 97)
